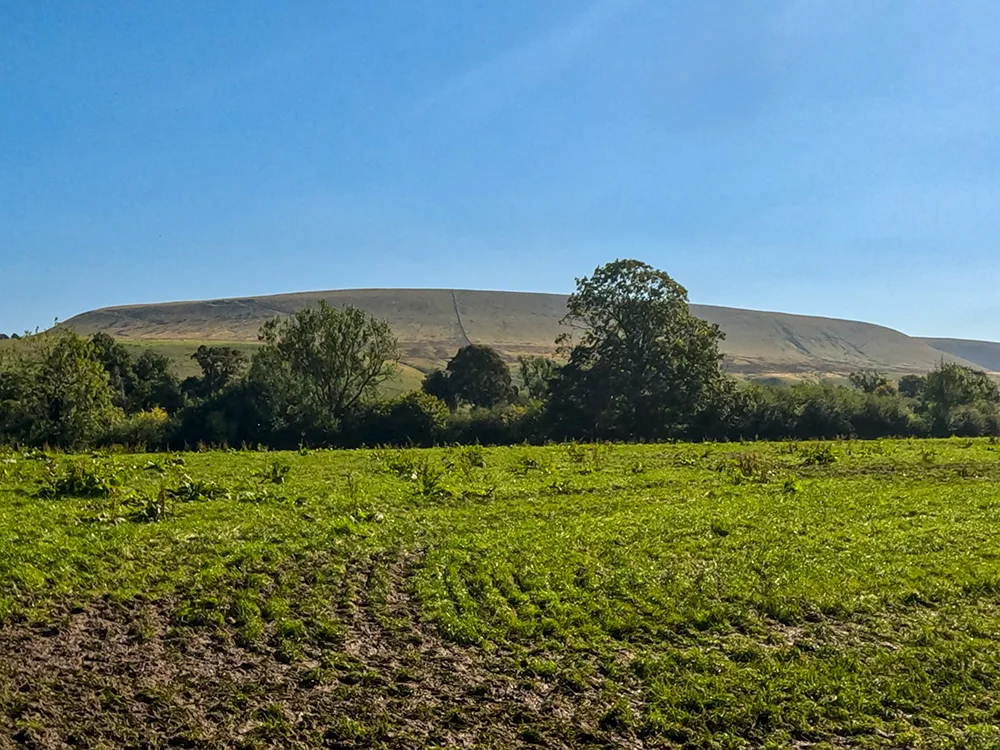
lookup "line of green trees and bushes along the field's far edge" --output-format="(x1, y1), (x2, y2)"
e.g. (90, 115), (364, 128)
(0, 260), (1000, 448)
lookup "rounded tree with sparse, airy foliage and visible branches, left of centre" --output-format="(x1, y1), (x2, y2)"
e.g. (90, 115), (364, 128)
(249, 302), (399, 435)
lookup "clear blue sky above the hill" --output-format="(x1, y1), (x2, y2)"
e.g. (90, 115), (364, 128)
(0, 0), (1000, 340)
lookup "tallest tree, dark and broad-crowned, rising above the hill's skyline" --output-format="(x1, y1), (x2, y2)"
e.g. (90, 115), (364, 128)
(549, 260), (726, 440)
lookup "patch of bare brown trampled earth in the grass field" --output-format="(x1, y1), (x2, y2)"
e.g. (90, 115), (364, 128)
(0, 561), (648, 748)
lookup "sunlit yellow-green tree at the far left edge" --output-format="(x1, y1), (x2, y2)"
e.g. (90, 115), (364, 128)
(0, 329), (122, 447)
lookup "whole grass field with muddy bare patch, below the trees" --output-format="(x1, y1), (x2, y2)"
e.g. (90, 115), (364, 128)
(0, 440), (1000, 748)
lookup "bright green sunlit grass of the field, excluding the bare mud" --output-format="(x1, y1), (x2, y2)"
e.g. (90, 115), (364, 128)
(0, 440), (1000, 747)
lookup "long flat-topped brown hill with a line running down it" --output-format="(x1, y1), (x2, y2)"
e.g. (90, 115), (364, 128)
(65, 289), (1000, 377)
